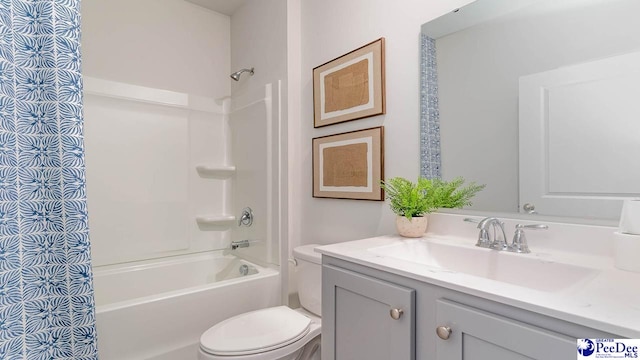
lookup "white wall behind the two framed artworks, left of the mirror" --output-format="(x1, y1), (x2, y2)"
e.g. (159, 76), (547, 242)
(296, 0), (470, 244)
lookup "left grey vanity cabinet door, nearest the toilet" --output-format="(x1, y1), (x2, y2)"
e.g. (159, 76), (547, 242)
(322, 265), (415, 360)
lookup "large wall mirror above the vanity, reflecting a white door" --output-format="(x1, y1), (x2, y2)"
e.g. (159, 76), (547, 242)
(421, 0), (640, 219)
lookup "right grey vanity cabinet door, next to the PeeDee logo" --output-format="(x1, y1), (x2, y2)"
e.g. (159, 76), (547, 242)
(432, 300), (577, 360)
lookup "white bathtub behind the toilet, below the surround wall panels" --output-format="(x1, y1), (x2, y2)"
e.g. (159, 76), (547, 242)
(93, 252), (280, 360)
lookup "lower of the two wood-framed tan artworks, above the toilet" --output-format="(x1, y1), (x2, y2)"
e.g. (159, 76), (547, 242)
(313, 126), (384, 201)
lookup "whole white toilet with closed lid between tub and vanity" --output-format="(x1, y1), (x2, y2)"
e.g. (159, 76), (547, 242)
(198, 244), (322, 360)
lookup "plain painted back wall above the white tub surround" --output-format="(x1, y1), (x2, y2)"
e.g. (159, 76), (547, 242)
(82, 0), (230, 98)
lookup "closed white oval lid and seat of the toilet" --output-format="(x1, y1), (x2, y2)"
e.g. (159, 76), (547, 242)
(200, 306), (311, 355)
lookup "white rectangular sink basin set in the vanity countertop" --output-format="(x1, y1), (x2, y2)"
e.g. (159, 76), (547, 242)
(369, 239), (598, 292)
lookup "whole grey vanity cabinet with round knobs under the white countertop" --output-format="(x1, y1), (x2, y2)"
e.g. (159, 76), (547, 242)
(322, 255), (621, 360)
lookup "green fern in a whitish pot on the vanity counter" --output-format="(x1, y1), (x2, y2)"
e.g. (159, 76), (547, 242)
(380, 177), (485, 237)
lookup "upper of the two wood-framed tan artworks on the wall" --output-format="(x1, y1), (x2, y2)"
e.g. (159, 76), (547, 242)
(313, 38), (385, 128)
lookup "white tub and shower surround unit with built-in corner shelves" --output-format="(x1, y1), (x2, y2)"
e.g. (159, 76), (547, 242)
(85, 77), (280, 360)
